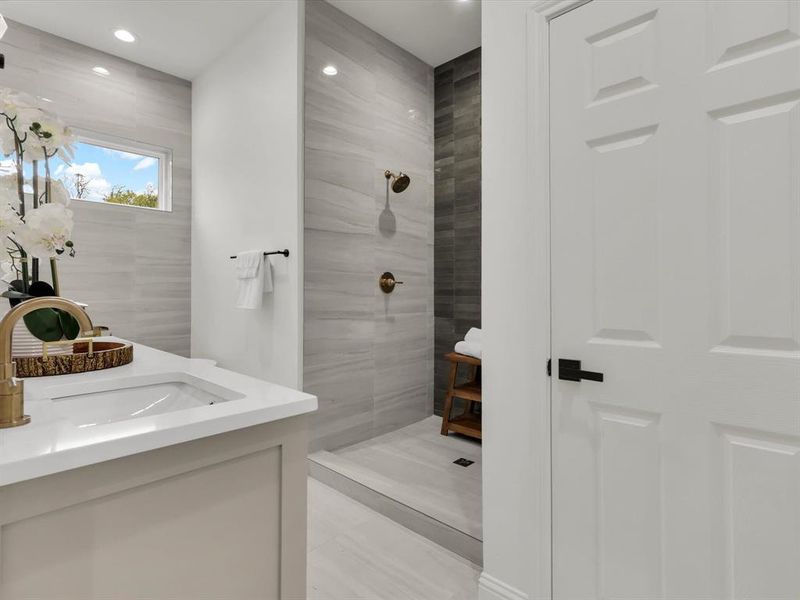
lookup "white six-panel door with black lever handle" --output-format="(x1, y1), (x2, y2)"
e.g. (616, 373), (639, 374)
(550, 0), (800, 600)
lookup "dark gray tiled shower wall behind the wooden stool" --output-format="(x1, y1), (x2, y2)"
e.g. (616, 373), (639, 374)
(434, 48), (481, 413)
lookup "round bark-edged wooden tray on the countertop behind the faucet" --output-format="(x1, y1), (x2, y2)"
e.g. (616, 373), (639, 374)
(14, 341), (133, 377)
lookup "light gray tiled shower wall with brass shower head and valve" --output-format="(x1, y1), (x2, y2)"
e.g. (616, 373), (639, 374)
(304, 0), (434, 450)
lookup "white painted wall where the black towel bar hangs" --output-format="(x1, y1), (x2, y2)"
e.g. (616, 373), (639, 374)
(192, 0), (304, 387)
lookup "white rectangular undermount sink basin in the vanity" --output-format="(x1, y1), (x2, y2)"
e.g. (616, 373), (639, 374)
(47, 373), (244, 428)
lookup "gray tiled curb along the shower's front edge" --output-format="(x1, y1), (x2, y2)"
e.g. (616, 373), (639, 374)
(308, 452), (483, 567)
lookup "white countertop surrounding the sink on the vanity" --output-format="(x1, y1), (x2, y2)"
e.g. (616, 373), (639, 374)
(0, 337), (317, 486)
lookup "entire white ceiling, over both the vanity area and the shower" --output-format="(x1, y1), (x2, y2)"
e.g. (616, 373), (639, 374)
(0, 0), (481, 79)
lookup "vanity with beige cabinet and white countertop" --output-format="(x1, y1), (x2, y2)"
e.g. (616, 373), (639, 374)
(0, 347), (316, 600)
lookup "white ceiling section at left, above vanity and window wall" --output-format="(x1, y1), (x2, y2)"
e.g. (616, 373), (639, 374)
(0, 0), (278, 79)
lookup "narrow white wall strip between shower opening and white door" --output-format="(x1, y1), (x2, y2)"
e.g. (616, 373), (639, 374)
(480, 0), (550, 600)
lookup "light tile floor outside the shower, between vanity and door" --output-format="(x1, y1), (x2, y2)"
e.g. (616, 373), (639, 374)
(308, 479), (480, 600)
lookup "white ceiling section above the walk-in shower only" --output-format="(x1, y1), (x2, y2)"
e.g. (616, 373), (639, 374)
(328, 0), (481, 67)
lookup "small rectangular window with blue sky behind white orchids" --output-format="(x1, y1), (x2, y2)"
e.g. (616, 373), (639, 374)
(50, 131), (172, 211)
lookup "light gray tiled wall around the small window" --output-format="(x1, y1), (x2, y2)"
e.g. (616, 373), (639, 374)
(0, 22), (191, 355)
